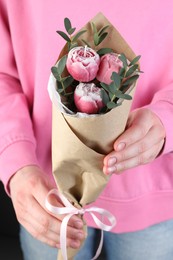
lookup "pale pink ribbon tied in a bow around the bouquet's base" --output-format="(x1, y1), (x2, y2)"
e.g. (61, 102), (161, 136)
(45, 189), (116, 260)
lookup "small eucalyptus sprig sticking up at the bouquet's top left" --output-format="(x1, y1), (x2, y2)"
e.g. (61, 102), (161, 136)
(56, 17), (86, 50)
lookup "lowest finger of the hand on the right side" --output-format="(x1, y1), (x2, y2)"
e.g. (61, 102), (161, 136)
(103, 141), (163, 175)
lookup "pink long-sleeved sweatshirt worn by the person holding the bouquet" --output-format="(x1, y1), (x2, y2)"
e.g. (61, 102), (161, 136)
(0, 0), (173, 232)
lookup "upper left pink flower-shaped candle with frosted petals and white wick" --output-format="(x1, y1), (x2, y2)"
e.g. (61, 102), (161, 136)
(66, 46), (100, 82)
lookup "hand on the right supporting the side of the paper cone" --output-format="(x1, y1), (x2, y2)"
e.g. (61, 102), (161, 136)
(103, 108), (165, 175)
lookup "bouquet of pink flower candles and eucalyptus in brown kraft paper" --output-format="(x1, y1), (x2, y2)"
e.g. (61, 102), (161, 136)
(48, 13), (140, 259)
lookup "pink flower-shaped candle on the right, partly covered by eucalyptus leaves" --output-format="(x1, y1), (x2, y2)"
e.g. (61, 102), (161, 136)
(97, 53), (123, 84)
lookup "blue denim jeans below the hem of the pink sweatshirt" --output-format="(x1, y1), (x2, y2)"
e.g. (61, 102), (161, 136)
(20, 220), (173, 260)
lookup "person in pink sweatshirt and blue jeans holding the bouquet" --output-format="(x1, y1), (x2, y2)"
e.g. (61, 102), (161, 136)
(0, 0), (173, 260)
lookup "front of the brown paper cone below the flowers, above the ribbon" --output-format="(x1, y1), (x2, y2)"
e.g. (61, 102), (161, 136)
(52, 87), (136, 207)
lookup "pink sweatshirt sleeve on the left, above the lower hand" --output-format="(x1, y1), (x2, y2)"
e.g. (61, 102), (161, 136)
(0, 1), (38, 191)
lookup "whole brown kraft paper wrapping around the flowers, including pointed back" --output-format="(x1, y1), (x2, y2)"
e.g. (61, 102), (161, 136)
(49, 13), (136, 260)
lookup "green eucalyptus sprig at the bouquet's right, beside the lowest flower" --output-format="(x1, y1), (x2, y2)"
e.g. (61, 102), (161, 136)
(100, 54), (142, 111)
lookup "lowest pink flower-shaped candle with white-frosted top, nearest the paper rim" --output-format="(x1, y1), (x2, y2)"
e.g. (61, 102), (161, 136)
(74, 83), (104, 114)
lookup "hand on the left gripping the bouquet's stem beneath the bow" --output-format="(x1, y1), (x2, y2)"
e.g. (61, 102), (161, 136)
(9, 166), (84, 248)
